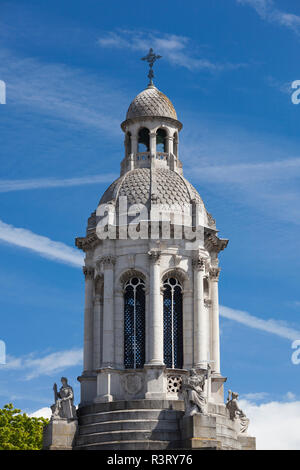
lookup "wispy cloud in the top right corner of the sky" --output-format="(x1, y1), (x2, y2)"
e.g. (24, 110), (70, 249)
(237, 0), (300, 34)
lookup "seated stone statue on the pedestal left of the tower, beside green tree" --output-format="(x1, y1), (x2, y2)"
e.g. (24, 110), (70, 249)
(51, 377), (77, 420)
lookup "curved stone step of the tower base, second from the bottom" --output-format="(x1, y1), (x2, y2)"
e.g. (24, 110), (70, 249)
(76, 429), (181, 446)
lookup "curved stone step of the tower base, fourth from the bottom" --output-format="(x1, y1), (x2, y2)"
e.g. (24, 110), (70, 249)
(79, 409), (183, 425)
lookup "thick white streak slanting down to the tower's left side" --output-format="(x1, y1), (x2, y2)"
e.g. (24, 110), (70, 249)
(0, 220), (84, 267)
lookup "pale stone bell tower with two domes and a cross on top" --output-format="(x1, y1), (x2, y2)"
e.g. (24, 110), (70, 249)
(72, 50), (253, 449)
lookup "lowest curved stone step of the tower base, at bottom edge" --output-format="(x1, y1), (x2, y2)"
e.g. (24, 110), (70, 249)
(74, 440), (180, 450)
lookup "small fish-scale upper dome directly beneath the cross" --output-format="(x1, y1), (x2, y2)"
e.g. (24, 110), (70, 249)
(126, 85), (177, 119)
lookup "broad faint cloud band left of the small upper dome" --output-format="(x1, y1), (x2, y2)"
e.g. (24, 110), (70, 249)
(0, 48), (128, 135)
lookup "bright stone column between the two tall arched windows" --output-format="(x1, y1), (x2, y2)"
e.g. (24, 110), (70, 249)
(148, 250), (164, 365)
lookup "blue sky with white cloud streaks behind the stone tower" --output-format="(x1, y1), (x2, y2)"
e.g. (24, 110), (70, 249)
(0, 0), (300, 447)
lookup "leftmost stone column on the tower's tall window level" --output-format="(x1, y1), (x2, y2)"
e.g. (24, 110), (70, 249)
(83, 266), (94, 372)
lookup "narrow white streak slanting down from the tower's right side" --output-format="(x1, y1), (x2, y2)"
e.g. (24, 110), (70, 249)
(220, 306), (300, 341)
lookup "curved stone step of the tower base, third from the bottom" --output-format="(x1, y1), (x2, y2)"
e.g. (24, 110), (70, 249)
(79, 419), (179, 435)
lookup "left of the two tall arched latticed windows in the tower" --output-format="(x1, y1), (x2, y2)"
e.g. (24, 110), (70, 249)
(124, 277), (145, 369)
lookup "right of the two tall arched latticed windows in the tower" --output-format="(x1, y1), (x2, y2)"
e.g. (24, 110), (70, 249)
(164, 277), (183, 369)
